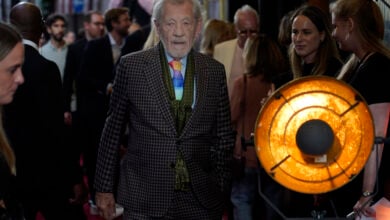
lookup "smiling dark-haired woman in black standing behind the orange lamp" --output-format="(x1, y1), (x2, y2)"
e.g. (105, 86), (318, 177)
(284, 4), (343, 218)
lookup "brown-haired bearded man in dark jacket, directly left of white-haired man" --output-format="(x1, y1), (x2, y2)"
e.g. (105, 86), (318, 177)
(77, 7), (131, 208)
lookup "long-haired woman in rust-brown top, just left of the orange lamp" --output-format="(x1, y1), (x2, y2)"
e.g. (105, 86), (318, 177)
(230, 35), (287, 220)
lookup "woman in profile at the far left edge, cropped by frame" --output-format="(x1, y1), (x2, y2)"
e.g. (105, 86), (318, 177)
(0, 22), (24, 220)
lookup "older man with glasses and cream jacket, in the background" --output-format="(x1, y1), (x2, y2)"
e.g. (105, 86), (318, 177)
(214, 5), (260, 97)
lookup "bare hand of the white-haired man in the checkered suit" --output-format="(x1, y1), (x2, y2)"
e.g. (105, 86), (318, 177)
(96, 192), (116, 220)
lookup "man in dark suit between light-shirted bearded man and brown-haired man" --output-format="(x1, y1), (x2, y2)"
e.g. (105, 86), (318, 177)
(63, 11), (105, 215)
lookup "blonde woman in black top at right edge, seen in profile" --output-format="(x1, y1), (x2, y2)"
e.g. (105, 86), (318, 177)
(331, 0), (390, 219)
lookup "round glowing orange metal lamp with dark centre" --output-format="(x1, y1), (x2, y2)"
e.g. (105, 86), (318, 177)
(254, 76), (374, 194)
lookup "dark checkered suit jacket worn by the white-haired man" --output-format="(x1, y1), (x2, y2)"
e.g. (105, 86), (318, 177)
(95, 43), (234, 216)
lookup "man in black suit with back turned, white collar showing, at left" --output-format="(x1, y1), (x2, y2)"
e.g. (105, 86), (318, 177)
(3, 2), (83, 220)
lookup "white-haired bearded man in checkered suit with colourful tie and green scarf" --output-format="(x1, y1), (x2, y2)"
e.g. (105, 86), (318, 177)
(95, 0), (234, 220)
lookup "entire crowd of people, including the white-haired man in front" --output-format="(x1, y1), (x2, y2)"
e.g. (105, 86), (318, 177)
(0, 0), (390, 220)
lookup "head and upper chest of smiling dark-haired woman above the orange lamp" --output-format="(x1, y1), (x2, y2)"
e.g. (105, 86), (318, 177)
(289, 5), (343, 78)
